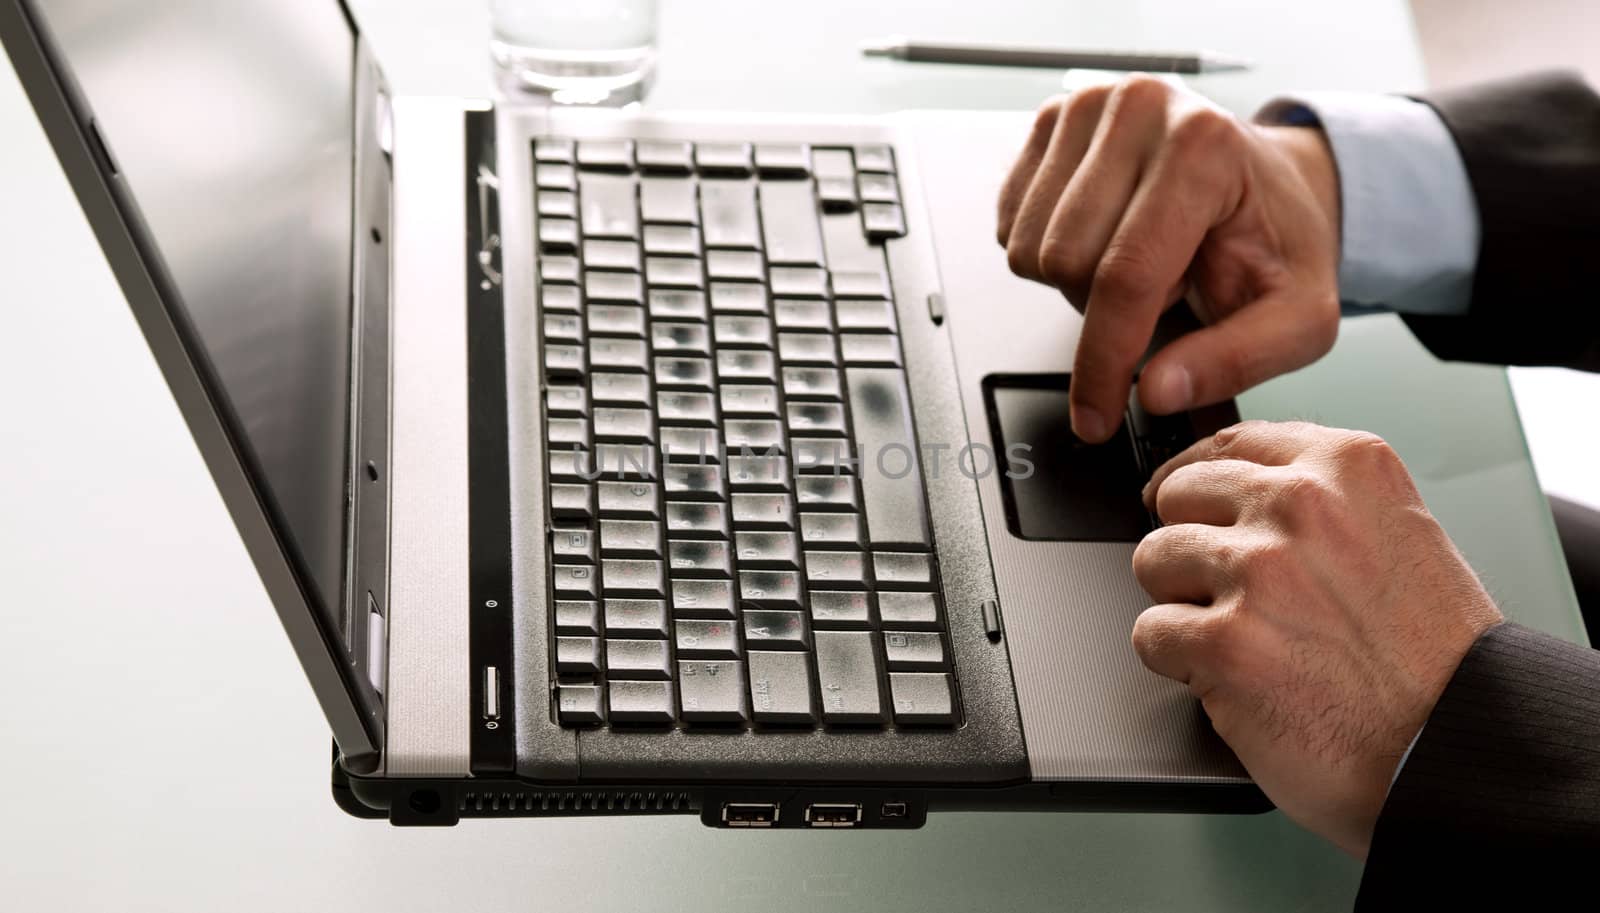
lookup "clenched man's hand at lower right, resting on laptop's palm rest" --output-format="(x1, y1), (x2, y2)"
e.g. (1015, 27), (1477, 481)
(1133, 422), (1502, 857)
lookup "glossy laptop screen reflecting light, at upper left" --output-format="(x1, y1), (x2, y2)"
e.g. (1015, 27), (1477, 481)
(34, 0), (355, 620)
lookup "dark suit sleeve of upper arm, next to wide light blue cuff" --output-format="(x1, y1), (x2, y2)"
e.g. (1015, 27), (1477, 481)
(1405, 72), (1600, 371)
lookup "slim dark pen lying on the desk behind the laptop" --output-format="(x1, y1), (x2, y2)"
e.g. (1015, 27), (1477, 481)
(861, 37), (1250, 74)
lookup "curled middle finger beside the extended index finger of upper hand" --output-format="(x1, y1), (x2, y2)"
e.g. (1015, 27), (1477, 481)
(1038, 80), (1171, 310)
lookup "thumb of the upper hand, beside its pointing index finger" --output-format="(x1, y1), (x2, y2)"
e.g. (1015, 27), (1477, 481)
(1139, 289), (1339, 414)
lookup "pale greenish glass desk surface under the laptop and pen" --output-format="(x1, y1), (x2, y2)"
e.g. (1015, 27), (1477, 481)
(0, 0), (1581, 913)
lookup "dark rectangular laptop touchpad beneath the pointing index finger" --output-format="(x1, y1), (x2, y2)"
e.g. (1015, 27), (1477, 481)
(984, 374), (1152, 542)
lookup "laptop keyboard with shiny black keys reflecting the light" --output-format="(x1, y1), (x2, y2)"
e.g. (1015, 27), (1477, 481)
(534, 139), (958, 728)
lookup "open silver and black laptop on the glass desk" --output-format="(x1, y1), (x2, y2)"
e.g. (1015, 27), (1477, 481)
(0, 0), (1267, 828)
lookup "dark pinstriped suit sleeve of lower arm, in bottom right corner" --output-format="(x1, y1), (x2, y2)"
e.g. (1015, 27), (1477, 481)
(1357, 624), (1600, 910)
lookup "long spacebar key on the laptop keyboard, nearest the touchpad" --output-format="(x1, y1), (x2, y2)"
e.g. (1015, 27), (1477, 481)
(845, 368), (933, 548)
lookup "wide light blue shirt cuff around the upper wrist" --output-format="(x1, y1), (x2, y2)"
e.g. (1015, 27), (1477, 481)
(1256, 93), (1478, 315)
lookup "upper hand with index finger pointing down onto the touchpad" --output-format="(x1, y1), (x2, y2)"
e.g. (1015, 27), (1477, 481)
(998, 77), (1339, 443)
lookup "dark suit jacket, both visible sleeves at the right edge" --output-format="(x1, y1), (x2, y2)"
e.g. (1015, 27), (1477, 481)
(1357, 74), (1600, 910)
